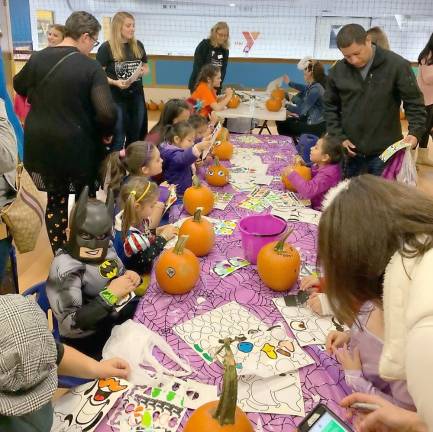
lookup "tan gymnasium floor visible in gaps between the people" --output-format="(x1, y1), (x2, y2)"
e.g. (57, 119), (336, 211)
(11, 111), (433, 292)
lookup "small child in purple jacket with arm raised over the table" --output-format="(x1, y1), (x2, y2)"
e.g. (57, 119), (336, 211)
(160, 122), (211, 197)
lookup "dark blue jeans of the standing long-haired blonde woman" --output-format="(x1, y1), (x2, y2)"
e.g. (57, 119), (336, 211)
(110, 92), (147, 151)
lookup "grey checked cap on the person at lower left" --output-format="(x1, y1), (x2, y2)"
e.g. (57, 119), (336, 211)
(0, 294), (57, 416)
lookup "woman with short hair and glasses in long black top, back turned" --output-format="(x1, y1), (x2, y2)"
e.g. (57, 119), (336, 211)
(14, 12), (116, 252)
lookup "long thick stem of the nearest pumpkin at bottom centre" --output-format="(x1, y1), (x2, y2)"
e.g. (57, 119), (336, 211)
(213, 338), (238, 426)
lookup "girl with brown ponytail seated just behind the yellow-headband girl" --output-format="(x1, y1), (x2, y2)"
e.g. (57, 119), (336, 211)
(103, 141), (170, 228)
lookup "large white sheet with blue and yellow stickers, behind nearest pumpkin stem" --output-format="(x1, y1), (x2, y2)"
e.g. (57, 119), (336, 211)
(174, 302), (313, 377)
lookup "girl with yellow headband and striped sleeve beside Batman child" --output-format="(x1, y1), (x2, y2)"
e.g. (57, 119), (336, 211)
(114, 177), (177, 275)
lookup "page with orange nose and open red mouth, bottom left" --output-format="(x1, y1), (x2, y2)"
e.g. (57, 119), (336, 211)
(51, 378), (130, 432)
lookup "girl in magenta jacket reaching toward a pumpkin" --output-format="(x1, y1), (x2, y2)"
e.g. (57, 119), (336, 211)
(283, 135), (343, 210)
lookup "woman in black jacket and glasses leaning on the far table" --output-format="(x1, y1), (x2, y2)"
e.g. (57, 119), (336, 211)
(188, 21), (229, 94)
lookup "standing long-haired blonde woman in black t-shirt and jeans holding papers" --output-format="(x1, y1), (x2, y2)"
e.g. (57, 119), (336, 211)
(96, 12), (149, 151)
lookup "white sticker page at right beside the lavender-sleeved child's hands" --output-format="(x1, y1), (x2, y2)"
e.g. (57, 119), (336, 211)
(273, 297), (348, 346)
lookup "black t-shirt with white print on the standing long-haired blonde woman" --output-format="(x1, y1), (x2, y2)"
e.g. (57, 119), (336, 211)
(96, 41), (147, 100)
